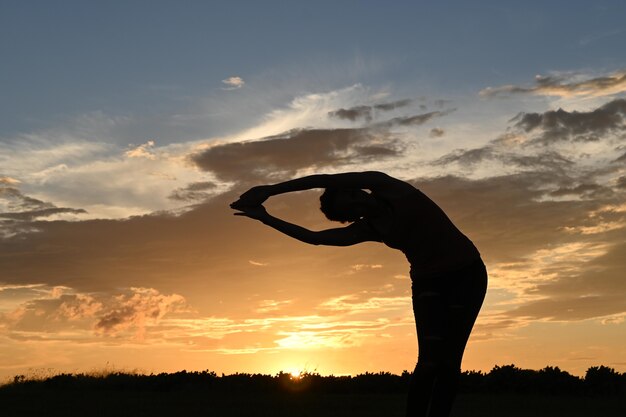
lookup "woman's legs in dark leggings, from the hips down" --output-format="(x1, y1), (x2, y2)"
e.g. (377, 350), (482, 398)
(407, 263), (487, 417)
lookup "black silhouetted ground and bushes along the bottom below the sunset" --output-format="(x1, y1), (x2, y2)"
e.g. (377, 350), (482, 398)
(0, 365), (626, 417)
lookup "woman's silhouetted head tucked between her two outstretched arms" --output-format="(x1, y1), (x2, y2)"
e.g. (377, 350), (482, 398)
(320, 187), (371, 223)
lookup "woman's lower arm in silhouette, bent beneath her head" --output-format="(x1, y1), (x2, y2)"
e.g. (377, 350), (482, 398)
(235, 206), (380, 246)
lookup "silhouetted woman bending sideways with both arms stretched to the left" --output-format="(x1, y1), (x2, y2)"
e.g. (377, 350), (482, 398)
(231, 171), (487, 417)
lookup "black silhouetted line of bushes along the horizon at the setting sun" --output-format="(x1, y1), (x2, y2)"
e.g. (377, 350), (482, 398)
(0, 365), (626, 396)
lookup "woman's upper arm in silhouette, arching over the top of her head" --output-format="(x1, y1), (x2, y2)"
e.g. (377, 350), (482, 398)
(231, 171), (411, 208)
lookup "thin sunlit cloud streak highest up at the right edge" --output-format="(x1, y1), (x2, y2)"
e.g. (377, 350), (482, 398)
(480, 70), (626, 97)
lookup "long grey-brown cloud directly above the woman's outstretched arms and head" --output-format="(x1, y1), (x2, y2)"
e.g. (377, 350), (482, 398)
(191, 128), (400, 182)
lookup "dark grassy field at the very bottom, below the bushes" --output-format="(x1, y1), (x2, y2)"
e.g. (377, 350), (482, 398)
(0, 390), (626, 417)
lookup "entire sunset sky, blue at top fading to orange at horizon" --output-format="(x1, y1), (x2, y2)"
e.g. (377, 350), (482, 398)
(0, 0), (626, 380)
